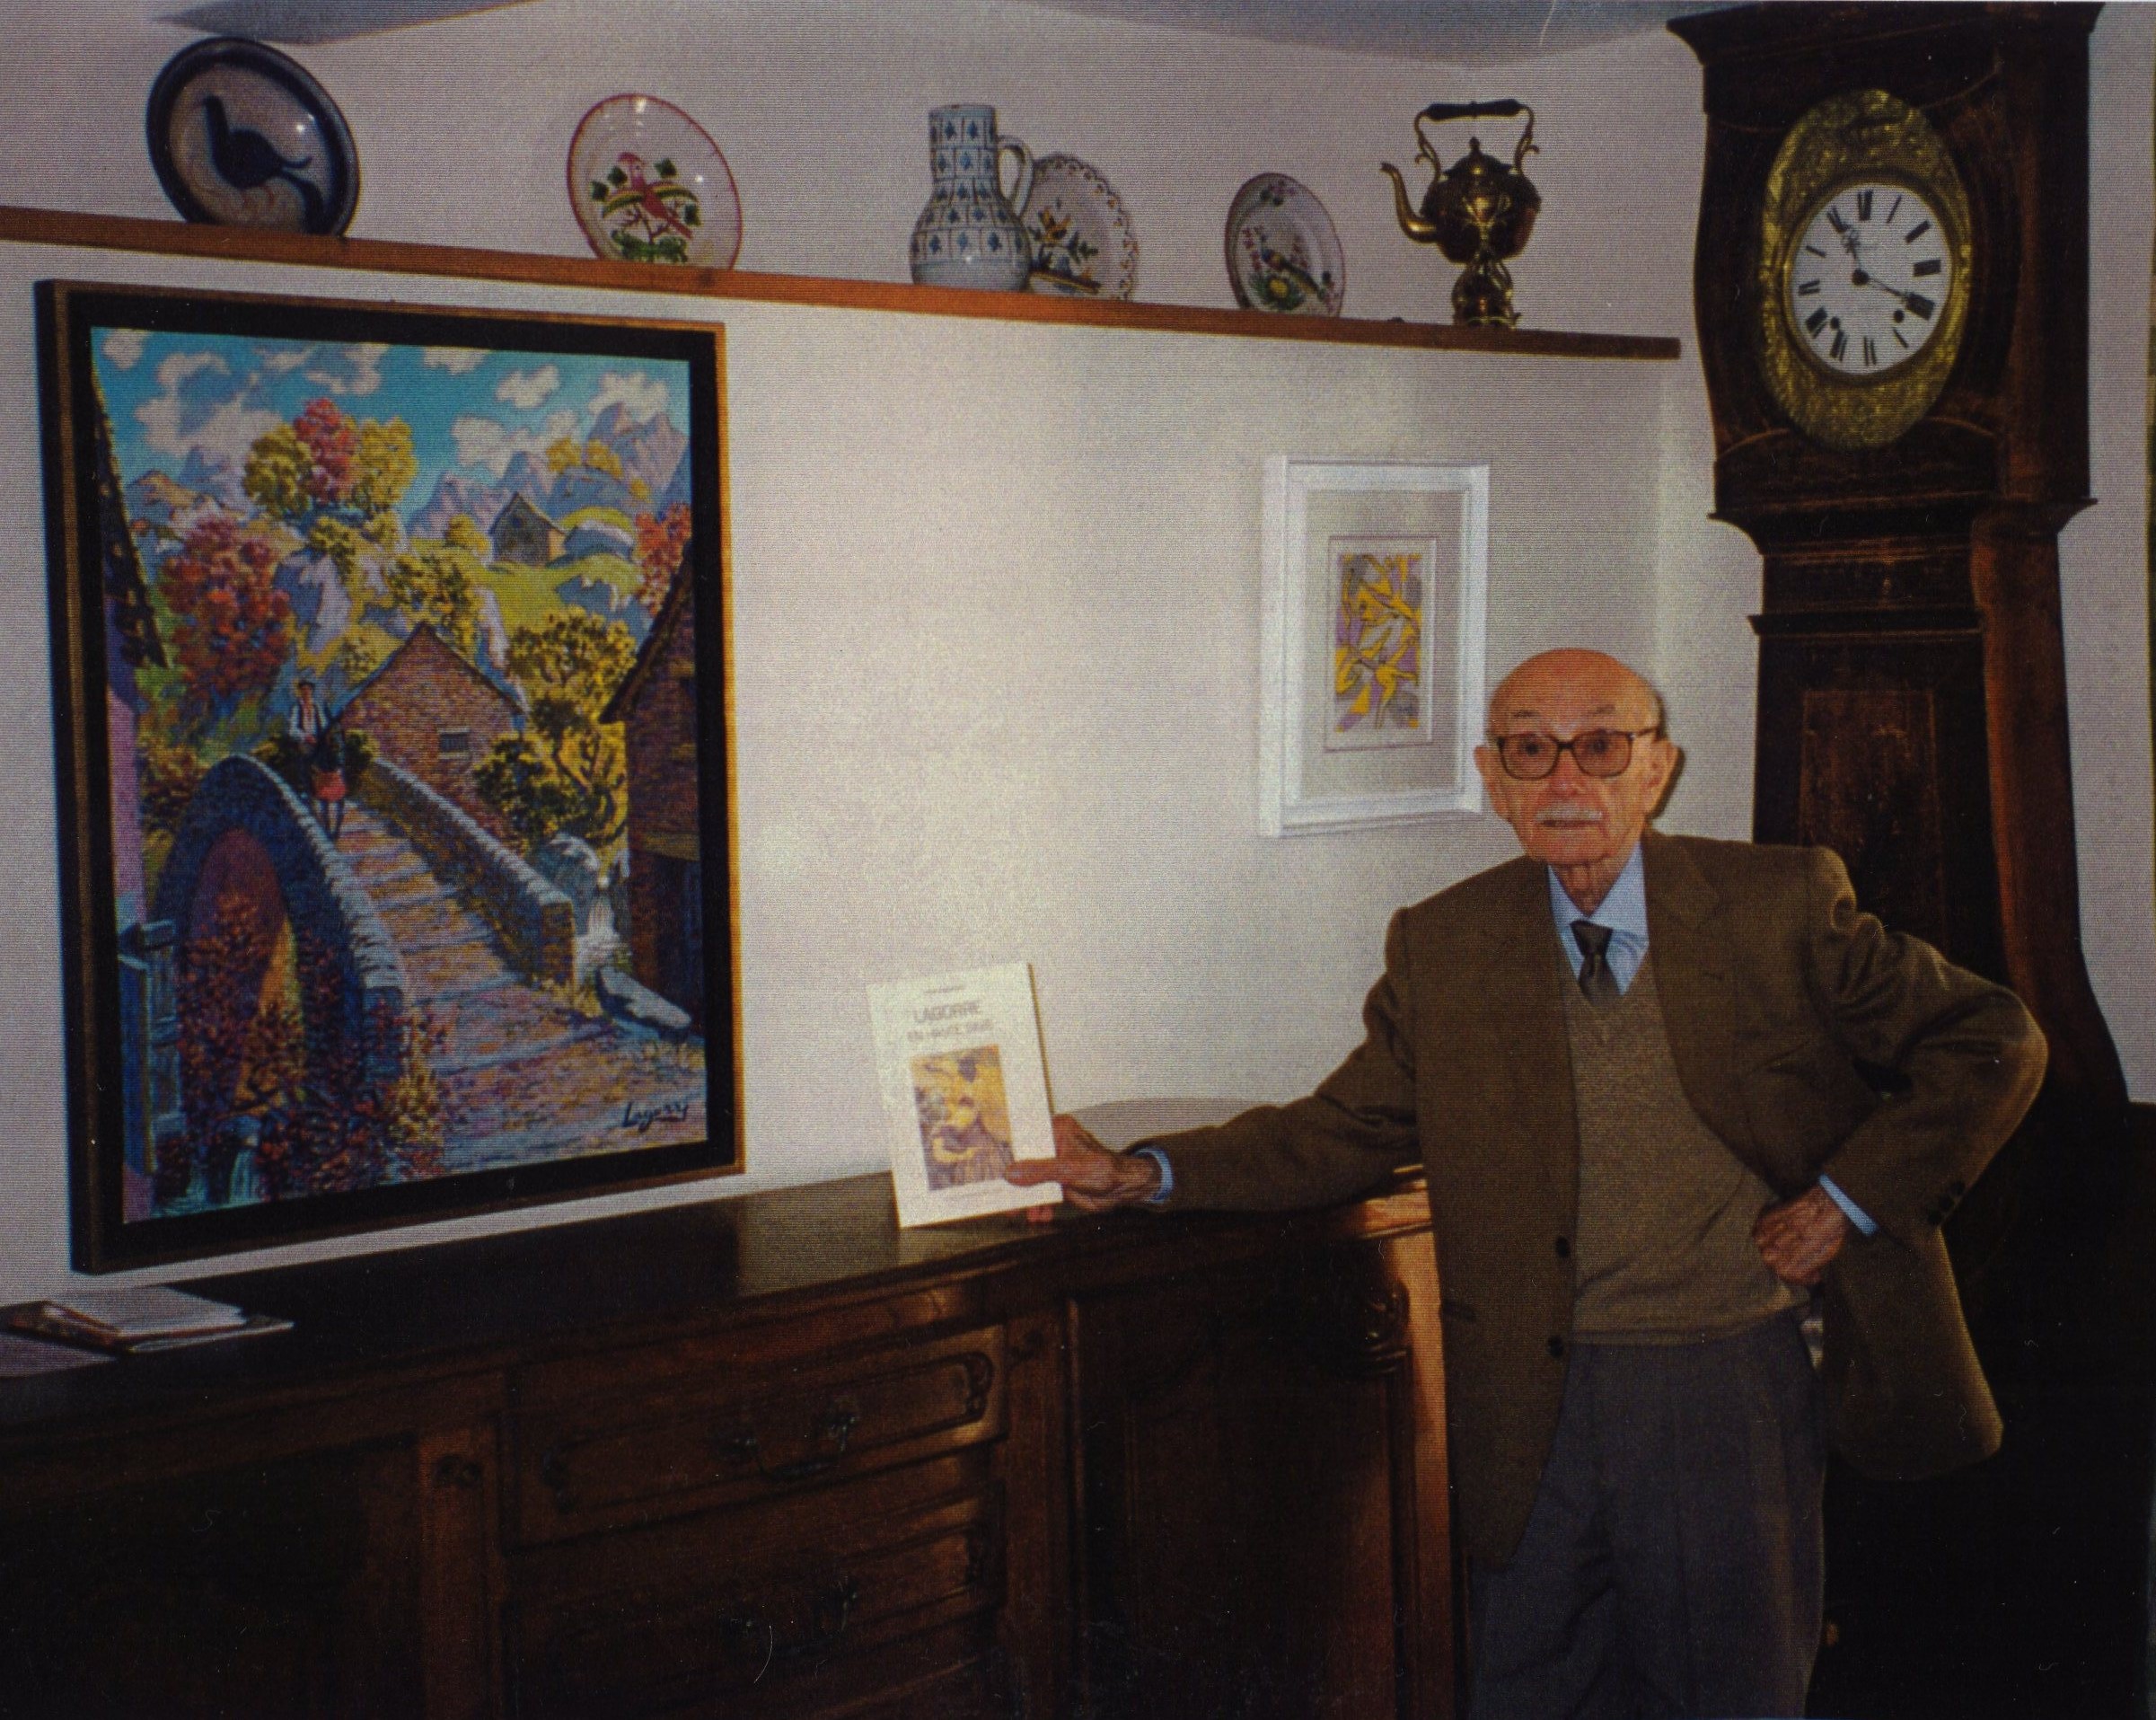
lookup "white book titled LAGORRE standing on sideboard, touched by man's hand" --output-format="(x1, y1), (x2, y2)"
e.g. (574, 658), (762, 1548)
(869, 961), (1063, 1226)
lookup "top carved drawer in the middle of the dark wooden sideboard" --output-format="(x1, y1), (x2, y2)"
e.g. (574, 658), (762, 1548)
(513, 1326), (1005, 1543)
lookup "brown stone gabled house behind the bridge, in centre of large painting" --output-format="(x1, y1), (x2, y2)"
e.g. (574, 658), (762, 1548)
(339, 623), (522, 841)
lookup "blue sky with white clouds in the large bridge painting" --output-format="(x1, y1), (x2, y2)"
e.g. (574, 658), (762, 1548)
(91, 328), (688, 513)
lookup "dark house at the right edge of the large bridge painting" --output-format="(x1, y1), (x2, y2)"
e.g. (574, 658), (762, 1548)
(599, 573), (705, 1032)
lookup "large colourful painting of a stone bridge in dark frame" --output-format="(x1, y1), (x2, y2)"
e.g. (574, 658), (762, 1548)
(39, 282), (742, 1272)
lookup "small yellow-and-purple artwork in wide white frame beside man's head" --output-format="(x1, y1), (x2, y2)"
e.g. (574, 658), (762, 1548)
(1259, 454), (1490, 836)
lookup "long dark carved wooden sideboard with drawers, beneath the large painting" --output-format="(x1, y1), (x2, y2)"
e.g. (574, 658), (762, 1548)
(0, 1177), (1456, 1720)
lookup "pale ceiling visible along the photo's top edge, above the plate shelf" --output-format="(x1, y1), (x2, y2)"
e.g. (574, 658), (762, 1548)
(160, 0), (1716, 65)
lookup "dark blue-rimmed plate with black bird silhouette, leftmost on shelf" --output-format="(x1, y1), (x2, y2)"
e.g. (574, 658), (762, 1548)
(145, 37), (360, 233)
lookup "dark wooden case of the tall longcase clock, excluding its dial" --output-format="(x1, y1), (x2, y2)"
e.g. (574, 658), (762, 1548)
(1673, 4), (2124, 1107)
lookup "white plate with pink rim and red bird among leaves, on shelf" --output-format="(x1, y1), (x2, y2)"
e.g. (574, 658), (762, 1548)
(569, 95), (742, 269)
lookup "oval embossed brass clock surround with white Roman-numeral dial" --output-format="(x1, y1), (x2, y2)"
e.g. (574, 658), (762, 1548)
(1757, 91), (1973, 451)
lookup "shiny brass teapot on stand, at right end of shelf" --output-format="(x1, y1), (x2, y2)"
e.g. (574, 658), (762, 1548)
(1382, 101), (1542, 328)
